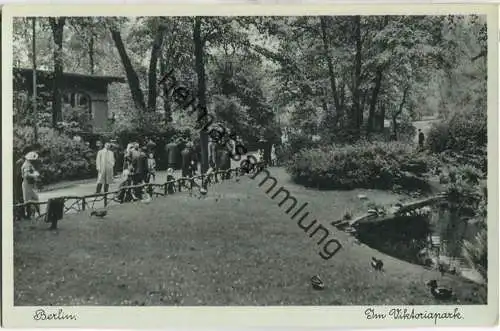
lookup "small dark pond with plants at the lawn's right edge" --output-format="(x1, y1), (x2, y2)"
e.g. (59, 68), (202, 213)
(356, 201), (483, 283)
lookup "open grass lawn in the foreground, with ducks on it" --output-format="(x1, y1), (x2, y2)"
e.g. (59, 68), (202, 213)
(14, 169), (481, 306)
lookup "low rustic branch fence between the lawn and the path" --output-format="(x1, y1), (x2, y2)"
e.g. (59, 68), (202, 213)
(14, 163), (264, 229)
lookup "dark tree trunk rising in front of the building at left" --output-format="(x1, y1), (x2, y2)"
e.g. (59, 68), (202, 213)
(49, 17), (66, 128)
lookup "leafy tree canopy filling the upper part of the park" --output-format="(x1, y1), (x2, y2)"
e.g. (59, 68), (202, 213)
(14, 15), (487, 152)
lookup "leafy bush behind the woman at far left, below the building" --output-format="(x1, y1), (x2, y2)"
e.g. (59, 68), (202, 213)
(14, 127), (96, 184)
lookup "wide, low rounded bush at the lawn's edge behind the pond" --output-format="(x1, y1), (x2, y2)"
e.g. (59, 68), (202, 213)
(287, 142), (436, 190)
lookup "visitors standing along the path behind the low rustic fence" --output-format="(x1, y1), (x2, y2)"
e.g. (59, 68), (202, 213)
(16, 134), (277, 217)
